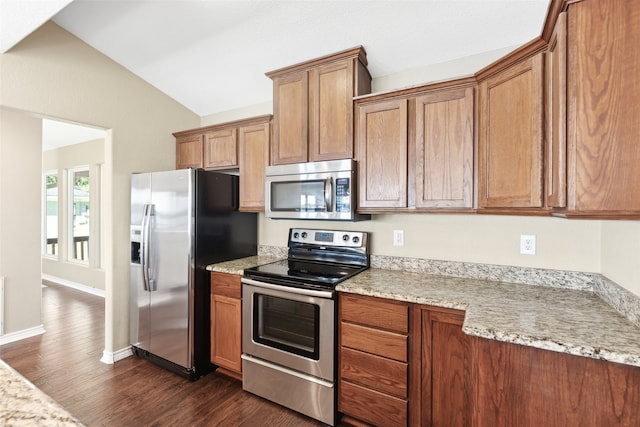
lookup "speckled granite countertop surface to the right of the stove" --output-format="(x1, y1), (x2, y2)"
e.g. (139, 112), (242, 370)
(336, 268), (640, 366)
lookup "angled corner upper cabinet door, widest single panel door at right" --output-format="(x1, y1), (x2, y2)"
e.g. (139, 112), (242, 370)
(478, 54), (543, 208)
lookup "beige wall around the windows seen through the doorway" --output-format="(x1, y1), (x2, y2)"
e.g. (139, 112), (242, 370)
(42, 139), (105, 291)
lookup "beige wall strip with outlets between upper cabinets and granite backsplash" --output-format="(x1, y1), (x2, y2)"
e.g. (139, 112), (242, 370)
(260, 214), (600, 272)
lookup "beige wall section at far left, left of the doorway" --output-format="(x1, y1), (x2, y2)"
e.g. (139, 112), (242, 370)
(0, 108), (42, 334)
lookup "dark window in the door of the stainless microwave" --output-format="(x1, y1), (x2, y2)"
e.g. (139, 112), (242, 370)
(271, 179), (327, 212)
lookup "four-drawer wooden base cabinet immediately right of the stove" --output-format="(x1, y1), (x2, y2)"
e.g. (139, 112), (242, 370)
(338, 294), (409, 426)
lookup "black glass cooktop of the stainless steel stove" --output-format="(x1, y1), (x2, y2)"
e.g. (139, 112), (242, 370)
(244, 259), (367, 289)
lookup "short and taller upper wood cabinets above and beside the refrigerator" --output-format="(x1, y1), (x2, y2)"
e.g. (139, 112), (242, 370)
(173, 115), (271, 212)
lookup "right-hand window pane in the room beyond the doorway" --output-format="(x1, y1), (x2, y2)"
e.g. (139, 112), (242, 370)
(71, 170), (90, 262)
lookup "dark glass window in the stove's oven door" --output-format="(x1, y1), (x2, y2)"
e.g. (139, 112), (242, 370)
(253, 294), (320, 360)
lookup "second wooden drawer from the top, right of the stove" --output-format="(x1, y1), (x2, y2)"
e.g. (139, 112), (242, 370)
(340, 322), (407, 362)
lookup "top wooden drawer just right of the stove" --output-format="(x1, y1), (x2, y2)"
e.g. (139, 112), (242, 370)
(340, 294), (409, 334)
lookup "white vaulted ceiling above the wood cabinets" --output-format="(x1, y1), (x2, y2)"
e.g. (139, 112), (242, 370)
(0, 0), (549, 116)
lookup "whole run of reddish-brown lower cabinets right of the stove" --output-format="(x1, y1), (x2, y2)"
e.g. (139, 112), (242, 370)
(338, 293), (640, 427)
